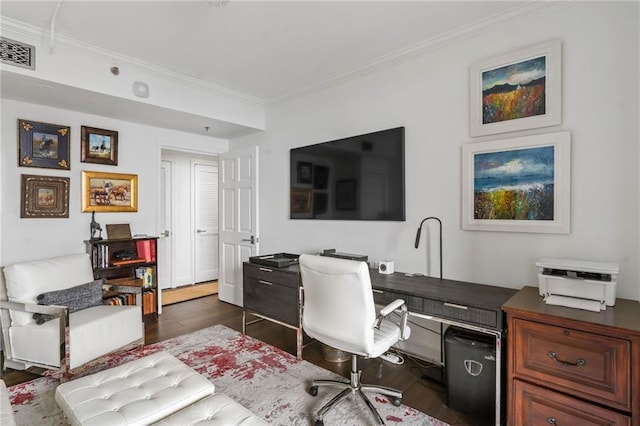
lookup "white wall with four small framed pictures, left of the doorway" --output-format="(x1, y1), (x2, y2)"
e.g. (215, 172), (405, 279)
(0, 99), (228, 265)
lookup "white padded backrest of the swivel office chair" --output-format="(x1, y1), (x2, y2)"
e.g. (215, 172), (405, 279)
(300, 254), (376, 356)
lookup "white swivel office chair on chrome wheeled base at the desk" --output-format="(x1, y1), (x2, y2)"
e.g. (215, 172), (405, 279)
(300, 254), (410, 426)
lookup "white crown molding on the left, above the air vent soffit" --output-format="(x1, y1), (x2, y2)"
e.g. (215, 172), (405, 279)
(0, 16), (264, 106)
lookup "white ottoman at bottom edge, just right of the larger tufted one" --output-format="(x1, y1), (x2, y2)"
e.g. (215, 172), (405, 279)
(157, 393), (268, 426)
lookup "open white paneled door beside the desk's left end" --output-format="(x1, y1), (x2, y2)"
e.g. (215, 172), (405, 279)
(218, 146), (260, 306)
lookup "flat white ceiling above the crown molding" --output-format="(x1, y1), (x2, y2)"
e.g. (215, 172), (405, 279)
(0, 0), (530, 136)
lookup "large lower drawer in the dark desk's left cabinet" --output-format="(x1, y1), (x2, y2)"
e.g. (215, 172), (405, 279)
(243, 276), (300, 327)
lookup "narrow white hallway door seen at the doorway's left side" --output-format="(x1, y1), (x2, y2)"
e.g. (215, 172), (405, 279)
(158, 160), (173, 289)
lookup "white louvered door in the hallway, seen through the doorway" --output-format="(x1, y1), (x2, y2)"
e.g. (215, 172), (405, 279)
(193, 162), (219, 283)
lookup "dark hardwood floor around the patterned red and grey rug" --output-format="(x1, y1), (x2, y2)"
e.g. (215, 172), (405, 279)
(2, 296), (478, 426)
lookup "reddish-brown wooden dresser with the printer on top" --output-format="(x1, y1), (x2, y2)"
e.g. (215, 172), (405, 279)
(502, 287), (640, 426)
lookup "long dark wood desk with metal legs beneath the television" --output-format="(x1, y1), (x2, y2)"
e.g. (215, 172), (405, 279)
(242, 262), (517, 425)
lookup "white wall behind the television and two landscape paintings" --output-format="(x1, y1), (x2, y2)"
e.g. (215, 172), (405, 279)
(231, 2), (640, 300)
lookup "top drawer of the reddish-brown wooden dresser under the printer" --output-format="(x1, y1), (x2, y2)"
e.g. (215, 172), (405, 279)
(512, 319), (631, 410)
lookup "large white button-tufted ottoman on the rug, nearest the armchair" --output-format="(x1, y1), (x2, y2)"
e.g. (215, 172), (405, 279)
(55, 352), (215, 426)
